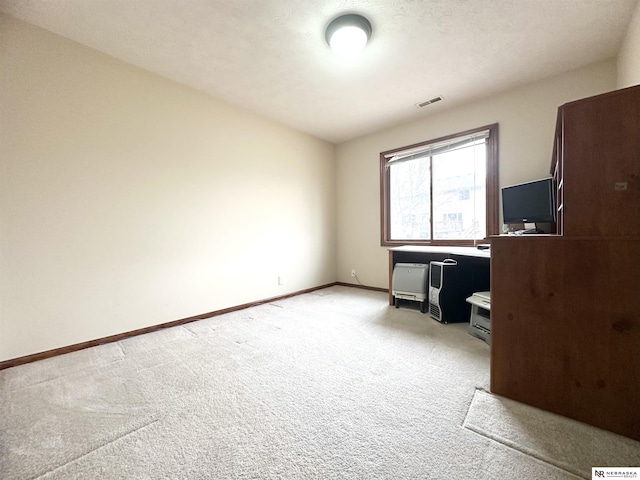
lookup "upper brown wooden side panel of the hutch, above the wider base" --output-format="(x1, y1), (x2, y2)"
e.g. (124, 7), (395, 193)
(561, 86), (640, 236)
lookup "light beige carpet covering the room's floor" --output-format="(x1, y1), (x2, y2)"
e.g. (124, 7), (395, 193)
(0, 287), (640, 480)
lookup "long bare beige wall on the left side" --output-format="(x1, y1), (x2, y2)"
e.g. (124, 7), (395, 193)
(0, 15), (336, 360)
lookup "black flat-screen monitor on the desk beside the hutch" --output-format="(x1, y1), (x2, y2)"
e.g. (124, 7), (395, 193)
(502, 178), (555, 223)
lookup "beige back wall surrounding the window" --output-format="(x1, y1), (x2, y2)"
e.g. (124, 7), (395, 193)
(336, 60), (616, 288)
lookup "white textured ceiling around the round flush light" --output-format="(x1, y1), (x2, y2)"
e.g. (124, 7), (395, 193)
(0, 0), (638, 143)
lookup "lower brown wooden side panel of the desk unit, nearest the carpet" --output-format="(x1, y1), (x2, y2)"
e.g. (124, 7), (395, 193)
(491, 237), (640, 440)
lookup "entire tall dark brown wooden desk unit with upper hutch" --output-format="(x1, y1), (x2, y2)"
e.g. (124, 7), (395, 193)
(491, 86), (640, 440)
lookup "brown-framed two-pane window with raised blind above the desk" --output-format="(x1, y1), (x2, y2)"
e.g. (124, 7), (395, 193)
(380, 124), (498, 245)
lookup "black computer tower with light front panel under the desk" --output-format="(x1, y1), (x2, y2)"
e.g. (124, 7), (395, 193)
(429, 259), (473, 323)
